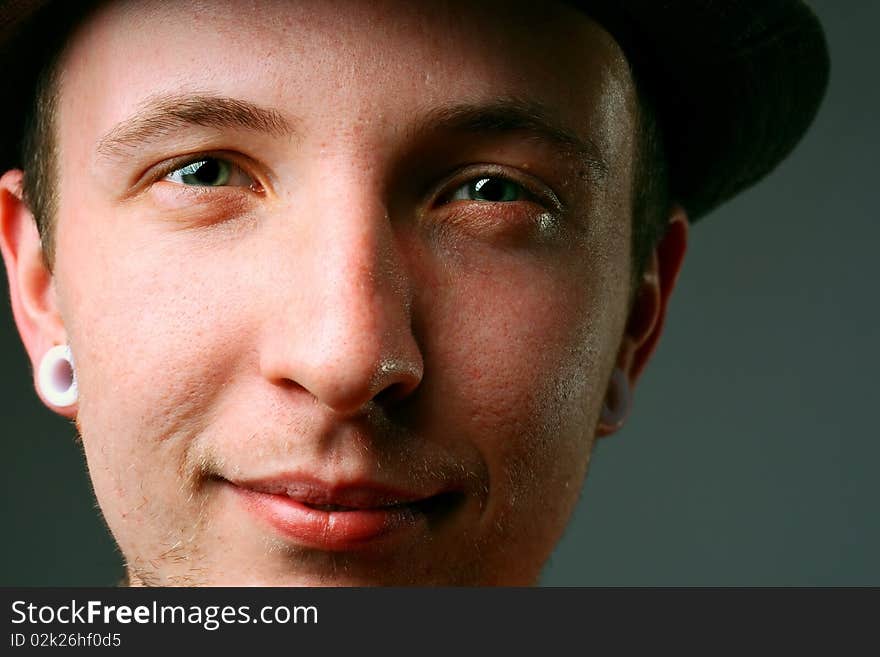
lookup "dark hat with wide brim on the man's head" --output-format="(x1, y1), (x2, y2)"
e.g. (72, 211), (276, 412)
(0, 0), (830, 221)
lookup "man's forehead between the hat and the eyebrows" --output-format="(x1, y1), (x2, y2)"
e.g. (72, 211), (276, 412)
(61, 0), (634, 160)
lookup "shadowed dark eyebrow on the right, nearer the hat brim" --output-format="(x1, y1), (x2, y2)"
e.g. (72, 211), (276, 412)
(419, 98), (609, 179)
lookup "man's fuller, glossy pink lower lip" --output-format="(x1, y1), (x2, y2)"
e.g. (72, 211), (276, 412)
(233, 486), (424, 551)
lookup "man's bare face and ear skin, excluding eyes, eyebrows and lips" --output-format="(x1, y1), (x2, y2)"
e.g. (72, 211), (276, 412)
(0, 0), (687, 585)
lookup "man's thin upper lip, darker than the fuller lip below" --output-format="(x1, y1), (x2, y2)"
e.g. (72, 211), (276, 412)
(227, 475), (445, 509)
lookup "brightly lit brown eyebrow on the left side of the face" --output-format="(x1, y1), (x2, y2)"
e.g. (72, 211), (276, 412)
(97, 94), (293, 156)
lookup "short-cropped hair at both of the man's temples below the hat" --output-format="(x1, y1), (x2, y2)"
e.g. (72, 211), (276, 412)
(20, 14), (671, 286)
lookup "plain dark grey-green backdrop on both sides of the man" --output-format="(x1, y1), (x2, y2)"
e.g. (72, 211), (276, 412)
(0, 0), (880, 586)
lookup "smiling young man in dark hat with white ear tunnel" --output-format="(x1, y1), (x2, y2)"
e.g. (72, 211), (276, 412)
(0, 0), (827, 585)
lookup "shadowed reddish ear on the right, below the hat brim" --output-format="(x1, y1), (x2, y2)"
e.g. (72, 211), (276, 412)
(596, 205), (689, 437)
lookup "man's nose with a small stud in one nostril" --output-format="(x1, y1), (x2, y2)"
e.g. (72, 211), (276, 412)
(260, 183), (424, 415)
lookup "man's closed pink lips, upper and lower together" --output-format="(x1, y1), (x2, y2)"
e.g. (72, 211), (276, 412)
(226, 478), (463, 551)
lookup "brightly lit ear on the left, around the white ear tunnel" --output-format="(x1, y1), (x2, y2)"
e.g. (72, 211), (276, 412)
(0, 170), (76, 418)
